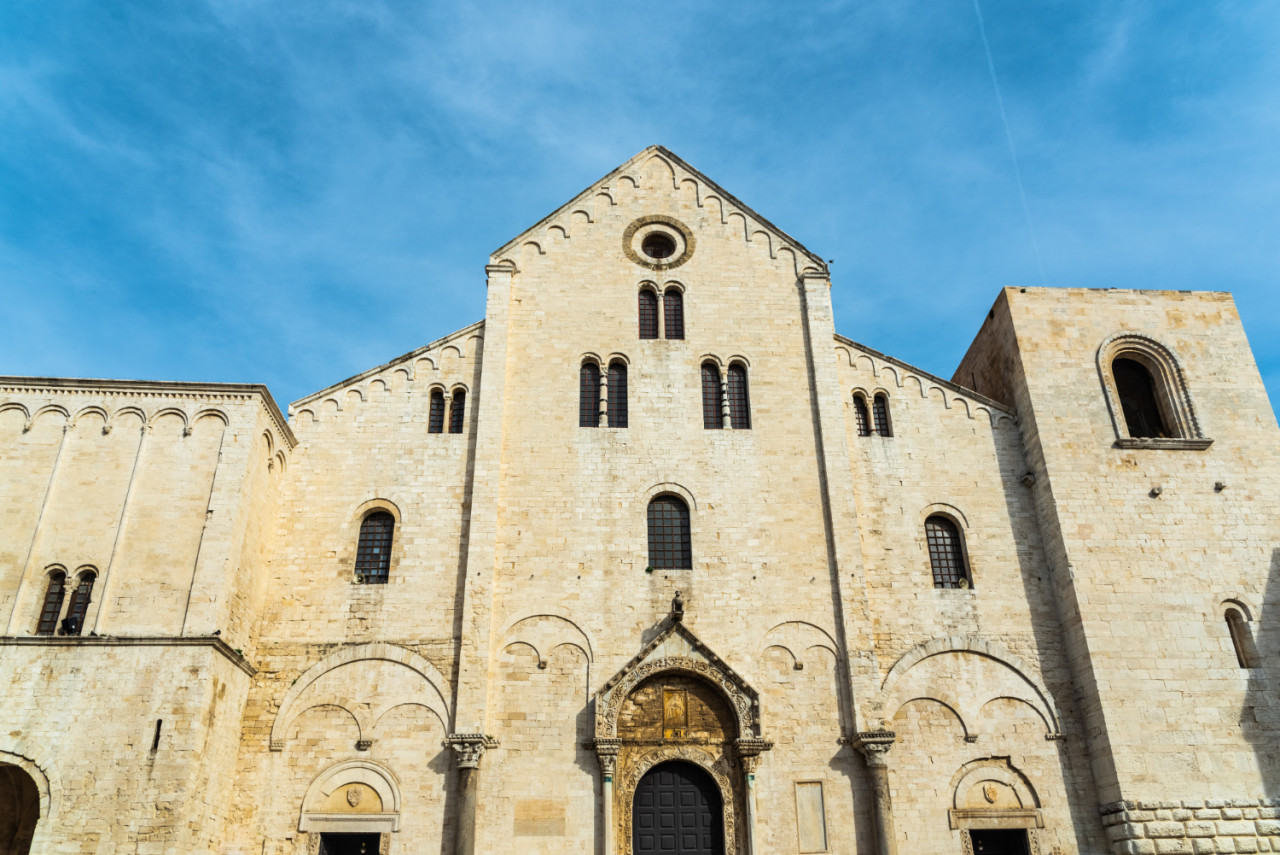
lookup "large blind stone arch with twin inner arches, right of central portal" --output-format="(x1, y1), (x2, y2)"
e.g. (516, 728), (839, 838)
(877, 636), (1062, 739)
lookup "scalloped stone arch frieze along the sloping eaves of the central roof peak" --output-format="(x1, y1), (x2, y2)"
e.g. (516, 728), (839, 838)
(489, 146), (827, 275)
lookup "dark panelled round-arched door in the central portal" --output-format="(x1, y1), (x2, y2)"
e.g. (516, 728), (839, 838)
(631, 760), (724, 855)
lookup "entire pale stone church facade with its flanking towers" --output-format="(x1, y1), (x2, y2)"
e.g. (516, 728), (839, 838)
(0, 147), (1280, 855)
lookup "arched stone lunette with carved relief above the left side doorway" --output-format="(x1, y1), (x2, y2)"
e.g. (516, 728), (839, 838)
(298, 759), (401, 832)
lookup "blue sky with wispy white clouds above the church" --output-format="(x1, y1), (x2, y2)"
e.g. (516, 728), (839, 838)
(0, 0), (1280, 414)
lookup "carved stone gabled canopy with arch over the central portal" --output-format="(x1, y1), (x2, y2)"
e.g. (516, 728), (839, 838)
(595, 616), (760, 740)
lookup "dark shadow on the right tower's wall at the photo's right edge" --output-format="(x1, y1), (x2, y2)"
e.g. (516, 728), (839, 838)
(1239, 548), (1280, 799)
